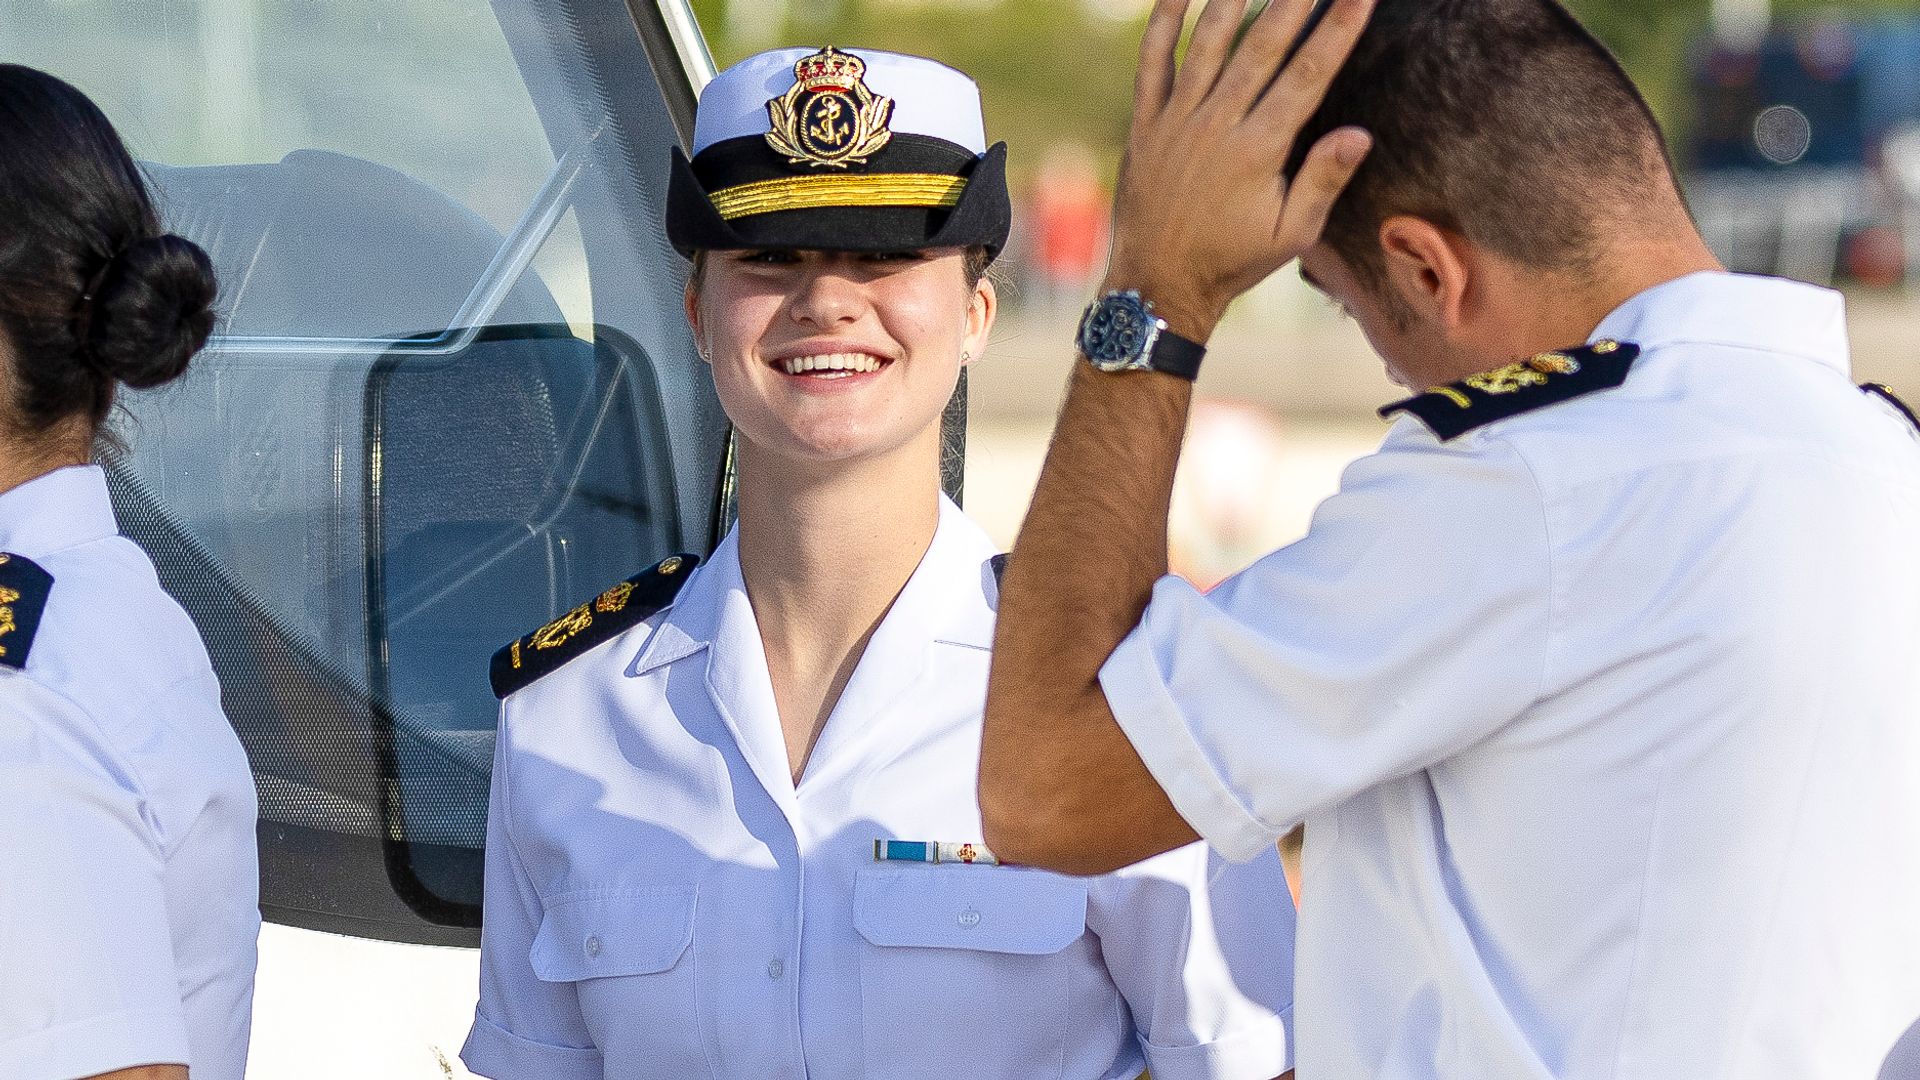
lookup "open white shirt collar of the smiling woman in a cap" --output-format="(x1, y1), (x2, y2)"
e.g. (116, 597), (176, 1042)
(630, 496), (998, 675)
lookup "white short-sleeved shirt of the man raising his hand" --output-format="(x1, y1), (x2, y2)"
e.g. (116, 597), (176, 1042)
(1102, 275), (1920, 1080)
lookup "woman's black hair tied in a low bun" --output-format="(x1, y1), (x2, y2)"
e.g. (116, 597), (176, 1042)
(0, 63), (215, 438)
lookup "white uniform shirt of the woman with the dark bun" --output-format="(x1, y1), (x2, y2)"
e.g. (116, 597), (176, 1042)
(0, 467), (259, 1080)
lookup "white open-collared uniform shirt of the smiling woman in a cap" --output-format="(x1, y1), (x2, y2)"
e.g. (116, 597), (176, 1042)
(463, 503), (1294, 1080)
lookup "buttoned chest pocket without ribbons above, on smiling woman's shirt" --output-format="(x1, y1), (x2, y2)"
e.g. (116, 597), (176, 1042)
(530, 886), (693, 982)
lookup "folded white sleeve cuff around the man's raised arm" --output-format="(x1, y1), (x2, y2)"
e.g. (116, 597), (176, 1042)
(1100, 578), (1281, 863)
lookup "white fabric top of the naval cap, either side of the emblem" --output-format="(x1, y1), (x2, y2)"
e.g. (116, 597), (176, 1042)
(693, 48), (987, 156)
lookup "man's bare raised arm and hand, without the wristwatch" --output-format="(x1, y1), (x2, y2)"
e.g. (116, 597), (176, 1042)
(979, 0), (1371, 872)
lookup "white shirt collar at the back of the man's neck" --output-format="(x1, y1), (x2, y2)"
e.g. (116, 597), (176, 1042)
(1590, 271), (1851, 375)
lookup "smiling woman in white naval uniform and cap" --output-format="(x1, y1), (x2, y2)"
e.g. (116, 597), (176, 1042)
(463, 50), (1292, 1080)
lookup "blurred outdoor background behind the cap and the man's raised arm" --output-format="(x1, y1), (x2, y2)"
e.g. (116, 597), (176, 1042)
(693, 0), (1920, 584)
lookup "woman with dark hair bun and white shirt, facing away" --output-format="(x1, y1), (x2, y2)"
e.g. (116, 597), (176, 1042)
(0, 65), (259, 1080)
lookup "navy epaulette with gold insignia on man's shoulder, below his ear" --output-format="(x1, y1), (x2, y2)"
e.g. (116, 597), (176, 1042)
(1380, 340), (1640, 442)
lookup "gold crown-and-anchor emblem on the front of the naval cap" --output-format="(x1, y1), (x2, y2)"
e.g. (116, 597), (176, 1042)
(766, 44), (893, 169)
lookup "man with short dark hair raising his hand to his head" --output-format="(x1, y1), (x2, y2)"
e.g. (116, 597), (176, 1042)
(981, 0), (1920, 1060)
